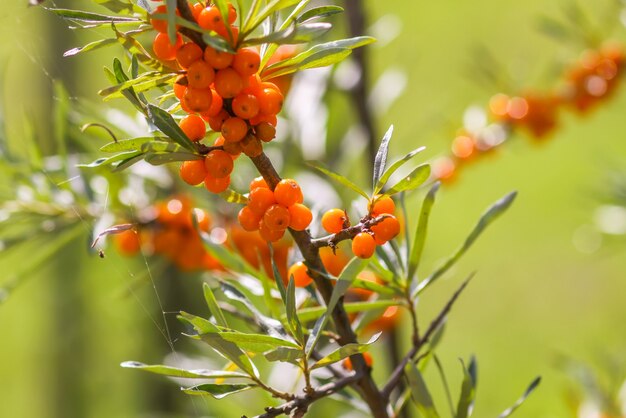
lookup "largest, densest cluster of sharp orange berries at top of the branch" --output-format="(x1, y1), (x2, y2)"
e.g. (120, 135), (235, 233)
(151, 3), (284, 193)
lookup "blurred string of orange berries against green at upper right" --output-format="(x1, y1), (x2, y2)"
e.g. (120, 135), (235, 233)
(432, 43), (626, 181)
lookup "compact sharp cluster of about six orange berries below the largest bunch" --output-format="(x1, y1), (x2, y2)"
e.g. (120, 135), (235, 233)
(237, 177), (313, 242)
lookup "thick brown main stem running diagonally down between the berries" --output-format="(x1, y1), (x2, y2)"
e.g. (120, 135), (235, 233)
(250, 153), (389, 418)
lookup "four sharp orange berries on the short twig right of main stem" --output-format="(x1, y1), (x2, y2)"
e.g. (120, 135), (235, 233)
(322, 195), (400, 258)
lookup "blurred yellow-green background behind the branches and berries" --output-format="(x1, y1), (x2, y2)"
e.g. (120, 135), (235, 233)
(0, 0), (626, 418)
